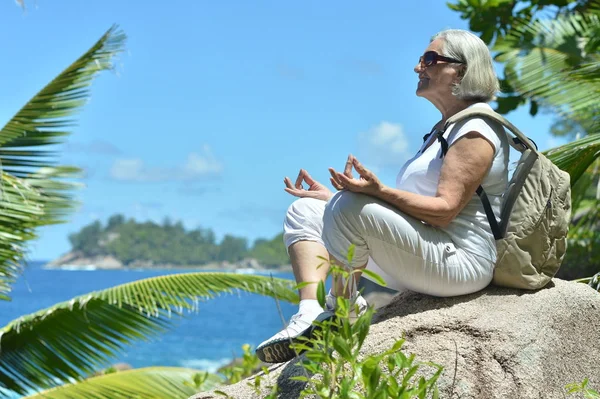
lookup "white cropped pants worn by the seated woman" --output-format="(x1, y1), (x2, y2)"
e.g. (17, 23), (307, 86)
(283, 191), (494, 296)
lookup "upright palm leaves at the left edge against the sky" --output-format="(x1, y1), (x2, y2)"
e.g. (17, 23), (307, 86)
(0, 26), (125, 300)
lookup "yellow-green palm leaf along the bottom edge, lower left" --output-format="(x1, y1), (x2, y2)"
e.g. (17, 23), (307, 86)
(24, 367), (223, 399)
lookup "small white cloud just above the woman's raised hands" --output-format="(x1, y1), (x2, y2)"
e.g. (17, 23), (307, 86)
(358, 121), (408, 167)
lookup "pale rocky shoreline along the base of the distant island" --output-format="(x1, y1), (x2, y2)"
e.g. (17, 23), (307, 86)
(44, 251), (292, 272)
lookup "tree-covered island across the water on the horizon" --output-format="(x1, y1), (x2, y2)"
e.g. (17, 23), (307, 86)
(45, 214), (291, 272)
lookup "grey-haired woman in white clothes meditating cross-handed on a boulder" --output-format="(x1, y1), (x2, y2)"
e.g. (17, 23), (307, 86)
(257, 30), (509, 363)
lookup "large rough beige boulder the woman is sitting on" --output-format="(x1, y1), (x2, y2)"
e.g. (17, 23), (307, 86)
(192, 279), (600, 399)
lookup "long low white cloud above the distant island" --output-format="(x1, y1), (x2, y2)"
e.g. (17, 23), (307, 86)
(110, 145), (223, 182)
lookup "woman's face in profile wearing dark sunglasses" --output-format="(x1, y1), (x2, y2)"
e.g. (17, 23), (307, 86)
(414, 39), (464, 103)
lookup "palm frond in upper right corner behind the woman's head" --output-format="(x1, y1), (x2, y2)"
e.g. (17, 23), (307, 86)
(494, 14), (600, 115)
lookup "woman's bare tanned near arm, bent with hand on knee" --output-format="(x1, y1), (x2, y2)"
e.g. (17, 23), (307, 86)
(330, 131), (494, 227)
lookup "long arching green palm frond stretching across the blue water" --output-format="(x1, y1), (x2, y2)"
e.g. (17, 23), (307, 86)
(0, 273), (298, 394)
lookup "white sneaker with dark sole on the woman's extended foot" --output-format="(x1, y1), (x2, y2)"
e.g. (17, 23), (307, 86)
(256, 311), (330, 363)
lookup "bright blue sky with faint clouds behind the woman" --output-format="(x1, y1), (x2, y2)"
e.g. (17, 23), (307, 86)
(0, 0), (560, 259)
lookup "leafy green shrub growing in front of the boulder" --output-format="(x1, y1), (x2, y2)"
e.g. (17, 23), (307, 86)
(293, 247), (443, 399)
